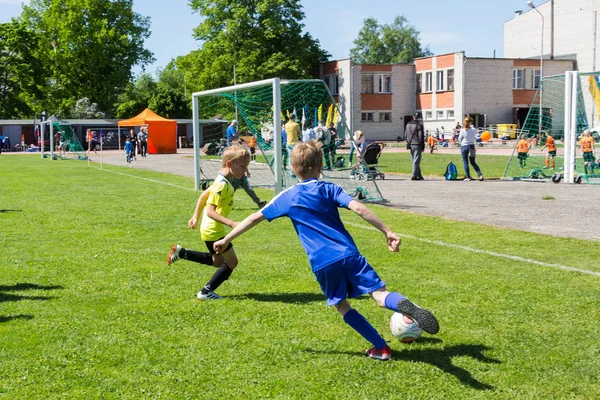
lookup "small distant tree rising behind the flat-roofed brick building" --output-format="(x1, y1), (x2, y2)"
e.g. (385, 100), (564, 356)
(350, 15), (433, 64)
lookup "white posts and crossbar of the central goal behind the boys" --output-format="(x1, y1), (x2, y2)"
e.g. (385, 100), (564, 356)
(192, 78), (283, 194)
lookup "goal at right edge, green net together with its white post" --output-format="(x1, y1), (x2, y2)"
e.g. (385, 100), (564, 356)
(503, 72), (600, 184)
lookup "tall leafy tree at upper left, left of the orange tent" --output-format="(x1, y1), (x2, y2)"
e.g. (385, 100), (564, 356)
(21, 0), (153, 114)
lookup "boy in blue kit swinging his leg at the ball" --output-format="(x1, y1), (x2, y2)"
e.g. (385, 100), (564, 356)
(214, 141), (439, 360)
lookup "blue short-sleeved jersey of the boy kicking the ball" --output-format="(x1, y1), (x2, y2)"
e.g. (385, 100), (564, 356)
(261, 179), (359, 272)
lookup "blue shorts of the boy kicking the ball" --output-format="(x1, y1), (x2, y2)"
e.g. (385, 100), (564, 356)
(315, 255), (385, 306)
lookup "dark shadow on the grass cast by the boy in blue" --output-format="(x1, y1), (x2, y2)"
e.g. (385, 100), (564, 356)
(306, 338), (501, 390)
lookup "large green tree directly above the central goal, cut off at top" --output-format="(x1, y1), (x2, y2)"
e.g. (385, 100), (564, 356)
(176, 0), (329, 91)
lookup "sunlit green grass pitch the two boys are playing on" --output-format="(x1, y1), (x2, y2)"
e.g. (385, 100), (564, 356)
(0, 155), (600, 399)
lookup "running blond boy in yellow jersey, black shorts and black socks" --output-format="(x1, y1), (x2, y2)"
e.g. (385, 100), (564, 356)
(167, 145), (250, 300)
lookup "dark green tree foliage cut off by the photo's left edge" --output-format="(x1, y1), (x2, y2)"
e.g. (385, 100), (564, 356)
(0, 20), (46, 119)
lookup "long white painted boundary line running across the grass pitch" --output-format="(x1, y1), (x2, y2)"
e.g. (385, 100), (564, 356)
(89, 167), (600, 276)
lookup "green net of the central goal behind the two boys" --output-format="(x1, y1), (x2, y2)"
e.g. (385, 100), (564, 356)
(195, 80), (385, 202)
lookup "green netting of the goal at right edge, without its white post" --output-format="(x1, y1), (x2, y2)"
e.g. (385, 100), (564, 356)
(503, 73), (600, 184)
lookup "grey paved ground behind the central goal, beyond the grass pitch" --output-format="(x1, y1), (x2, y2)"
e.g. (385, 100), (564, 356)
(85, 149), (600, 241)
